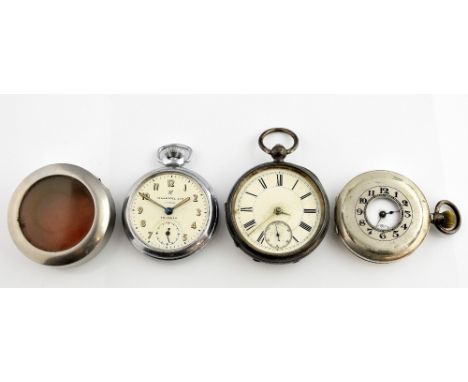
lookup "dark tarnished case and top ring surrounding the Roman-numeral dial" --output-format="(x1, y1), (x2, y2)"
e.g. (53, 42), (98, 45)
(225, 127), (330, 264)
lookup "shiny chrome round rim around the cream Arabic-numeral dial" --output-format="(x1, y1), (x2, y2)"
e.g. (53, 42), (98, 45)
(122, 167), (219, 260)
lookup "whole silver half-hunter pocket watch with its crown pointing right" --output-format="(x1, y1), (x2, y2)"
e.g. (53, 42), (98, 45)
(335, 171), (461, 263)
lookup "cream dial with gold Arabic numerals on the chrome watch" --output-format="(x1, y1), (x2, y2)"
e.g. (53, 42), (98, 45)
(128, 171), (210, 252)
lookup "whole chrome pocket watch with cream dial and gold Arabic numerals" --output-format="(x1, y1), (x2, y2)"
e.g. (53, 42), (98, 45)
(123, 144), (218, 260)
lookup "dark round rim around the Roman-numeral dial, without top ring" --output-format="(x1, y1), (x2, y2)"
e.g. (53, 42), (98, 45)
(226, 161), (330, 264)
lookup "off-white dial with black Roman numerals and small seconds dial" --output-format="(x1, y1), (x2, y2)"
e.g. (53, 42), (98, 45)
(233, 168), (324, 256)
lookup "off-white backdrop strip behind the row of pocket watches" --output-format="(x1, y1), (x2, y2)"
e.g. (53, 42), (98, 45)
(0, 95), (468, 287)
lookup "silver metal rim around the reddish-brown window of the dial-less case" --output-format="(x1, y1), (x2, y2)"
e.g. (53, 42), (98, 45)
(8, 163), (115, 266)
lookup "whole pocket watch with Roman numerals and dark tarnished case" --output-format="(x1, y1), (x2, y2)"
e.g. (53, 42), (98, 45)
(226, 128), (330, 263)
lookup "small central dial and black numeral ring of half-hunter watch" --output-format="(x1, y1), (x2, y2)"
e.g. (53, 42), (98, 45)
(355, 186), (413, 241)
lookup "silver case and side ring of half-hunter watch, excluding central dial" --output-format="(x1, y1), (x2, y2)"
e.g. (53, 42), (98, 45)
(335, 170), (461, 263)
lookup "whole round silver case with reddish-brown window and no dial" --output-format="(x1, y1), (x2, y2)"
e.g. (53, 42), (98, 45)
(8, 163), (115, 266)
